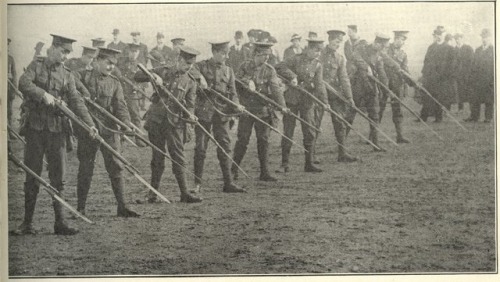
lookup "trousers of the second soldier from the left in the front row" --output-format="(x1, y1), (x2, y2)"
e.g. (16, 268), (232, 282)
(77, 129), (125, 211)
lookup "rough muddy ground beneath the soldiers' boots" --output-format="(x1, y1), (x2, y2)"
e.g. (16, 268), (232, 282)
(8, 101), (497, 276)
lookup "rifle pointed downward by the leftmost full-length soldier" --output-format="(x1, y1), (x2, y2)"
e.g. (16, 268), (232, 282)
(54, 100), (170, 203)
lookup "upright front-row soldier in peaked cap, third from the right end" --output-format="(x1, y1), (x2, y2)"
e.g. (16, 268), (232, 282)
(316, 30), (357, 162)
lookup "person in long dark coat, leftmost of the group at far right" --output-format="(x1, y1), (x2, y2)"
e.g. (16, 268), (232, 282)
(417, 26), (453, 122)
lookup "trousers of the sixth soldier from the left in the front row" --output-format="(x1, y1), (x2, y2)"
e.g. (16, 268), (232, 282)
(281, 103), (319, 167)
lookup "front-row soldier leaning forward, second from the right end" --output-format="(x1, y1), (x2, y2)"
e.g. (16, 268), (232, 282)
(346, 33), (390, 152)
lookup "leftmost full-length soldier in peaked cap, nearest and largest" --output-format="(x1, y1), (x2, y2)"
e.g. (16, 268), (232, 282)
(14, 34), (97, 235)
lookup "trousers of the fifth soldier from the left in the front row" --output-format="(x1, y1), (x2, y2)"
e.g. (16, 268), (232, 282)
(233, 115), (273, 175)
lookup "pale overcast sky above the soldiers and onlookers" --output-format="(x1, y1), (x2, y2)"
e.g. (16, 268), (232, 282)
(7, 2), (494, 74)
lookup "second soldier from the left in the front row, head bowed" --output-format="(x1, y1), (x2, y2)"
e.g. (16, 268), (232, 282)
(73, 48), (139, 217)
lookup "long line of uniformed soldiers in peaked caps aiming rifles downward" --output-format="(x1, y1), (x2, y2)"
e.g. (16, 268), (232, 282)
(9, 25), (491, 235)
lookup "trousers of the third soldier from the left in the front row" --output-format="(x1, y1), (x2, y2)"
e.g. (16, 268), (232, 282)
(148, 120), (187, 197)
